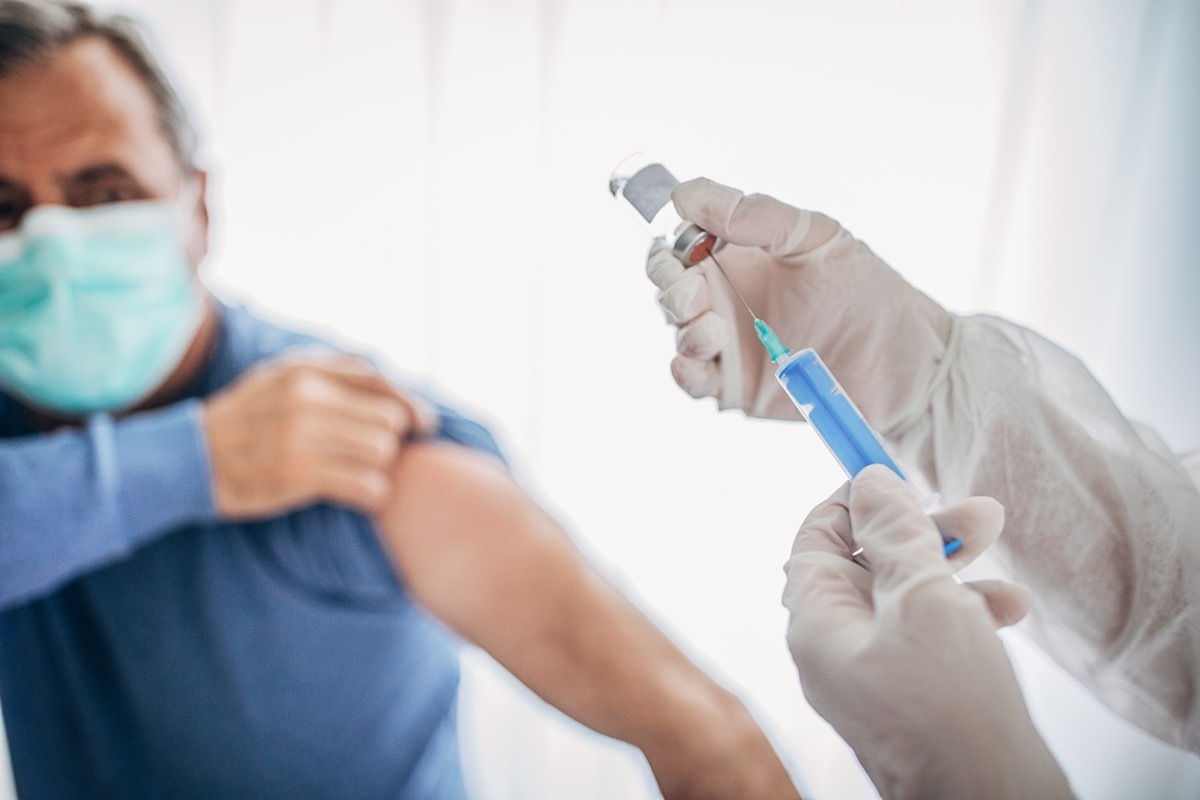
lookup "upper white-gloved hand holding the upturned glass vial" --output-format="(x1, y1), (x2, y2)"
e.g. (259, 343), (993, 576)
(647, 178), (952, 431)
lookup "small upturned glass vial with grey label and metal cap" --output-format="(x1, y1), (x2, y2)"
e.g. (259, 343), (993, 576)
(608, 154), (725, 266)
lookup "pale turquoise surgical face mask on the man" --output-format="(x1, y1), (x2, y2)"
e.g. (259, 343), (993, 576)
(0, 201), (203, 415)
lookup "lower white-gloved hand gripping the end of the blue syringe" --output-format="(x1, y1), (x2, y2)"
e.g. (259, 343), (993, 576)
(784, 467), (1072, 800)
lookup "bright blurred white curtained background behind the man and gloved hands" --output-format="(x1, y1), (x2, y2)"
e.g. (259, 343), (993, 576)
(4, 0), (1200, 800)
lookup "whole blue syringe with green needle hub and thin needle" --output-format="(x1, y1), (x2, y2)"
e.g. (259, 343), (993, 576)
(708, 252), (962, 557)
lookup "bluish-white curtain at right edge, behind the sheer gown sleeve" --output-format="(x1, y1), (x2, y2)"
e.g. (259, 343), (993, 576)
(976, 0), (1200, 800)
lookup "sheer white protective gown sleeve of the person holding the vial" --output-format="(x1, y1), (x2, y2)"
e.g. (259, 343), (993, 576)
(888, 315), (1200, 752)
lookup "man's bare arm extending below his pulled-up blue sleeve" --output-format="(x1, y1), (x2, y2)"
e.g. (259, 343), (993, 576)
(364, 445), (794, 798)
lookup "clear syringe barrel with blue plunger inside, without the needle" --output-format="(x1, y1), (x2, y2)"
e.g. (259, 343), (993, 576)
(775, 349), (908, 481)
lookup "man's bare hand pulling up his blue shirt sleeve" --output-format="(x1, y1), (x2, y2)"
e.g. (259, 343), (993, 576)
(204, 355), (436, 519)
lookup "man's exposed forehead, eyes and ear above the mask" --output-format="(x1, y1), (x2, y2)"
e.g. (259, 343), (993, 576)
(0, 37), (208, 262)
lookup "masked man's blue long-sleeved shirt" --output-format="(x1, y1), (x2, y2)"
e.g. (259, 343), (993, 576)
(0, 306), (499, 800)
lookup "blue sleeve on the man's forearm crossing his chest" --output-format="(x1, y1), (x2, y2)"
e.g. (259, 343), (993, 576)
(0, 401), (216, 608)
